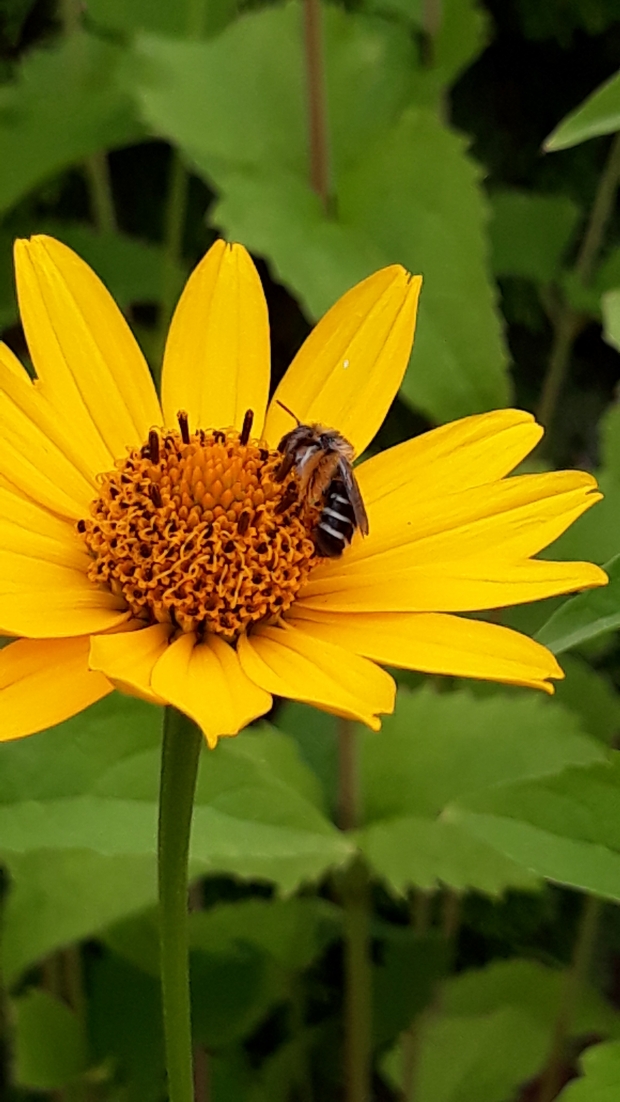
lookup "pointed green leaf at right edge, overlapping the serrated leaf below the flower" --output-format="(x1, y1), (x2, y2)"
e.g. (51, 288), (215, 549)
(444, 753), (620, 900)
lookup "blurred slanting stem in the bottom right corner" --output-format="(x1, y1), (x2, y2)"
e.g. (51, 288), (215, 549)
(536, 896), (601, 1102)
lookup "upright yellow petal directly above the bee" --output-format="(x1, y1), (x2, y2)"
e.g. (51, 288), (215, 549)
(265, 264), (422, 455)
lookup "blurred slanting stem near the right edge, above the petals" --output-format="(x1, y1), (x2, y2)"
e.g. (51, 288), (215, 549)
(537, 133), (620, 431)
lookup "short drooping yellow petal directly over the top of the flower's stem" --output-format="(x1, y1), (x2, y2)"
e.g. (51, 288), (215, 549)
(151, 634), (271, 748)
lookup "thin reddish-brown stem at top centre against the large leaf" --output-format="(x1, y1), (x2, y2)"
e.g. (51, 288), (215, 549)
(304, 0), (330, 212)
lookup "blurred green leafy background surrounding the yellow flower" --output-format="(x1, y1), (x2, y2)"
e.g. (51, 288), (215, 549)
(0, 0), (620, 1102)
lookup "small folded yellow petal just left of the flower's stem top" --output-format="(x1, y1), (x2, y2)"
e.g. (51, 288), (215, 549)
(88, 622), (173, 704)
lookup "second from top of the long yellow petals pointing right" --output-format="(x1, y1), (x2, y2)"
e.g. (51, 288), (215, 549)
(313, 471), (601, 577)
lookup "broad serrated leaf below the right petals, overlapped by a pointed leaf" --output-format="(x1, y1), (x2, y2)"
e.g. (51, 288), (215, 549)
(359, 688), (605, 894)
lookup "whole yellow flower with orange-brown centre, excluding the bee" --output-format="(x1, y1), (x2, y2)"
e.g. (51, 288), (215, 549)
(0, 237), (607, 746)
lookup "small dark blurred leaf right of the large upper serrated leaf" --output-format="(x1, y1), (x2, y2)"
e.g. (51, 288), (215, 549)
(489, 191), (579, 283)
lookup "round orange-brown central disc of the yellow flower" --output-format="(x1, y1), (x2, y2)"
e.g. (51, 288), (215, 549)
(77, 412), (320, 639)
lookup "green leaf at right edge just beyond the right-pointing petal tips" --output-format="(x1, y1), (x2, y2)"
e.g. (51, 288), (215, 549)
(536, 554), (620, 655)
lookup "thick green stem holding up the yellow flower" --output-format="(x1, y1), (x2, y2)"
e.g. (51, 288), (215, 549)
(157, 706), (203, 1102)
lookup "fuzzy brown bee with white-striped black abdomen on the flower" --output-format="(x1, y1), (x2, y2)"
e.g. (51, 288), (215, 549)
(275, 402), (368, 559)
